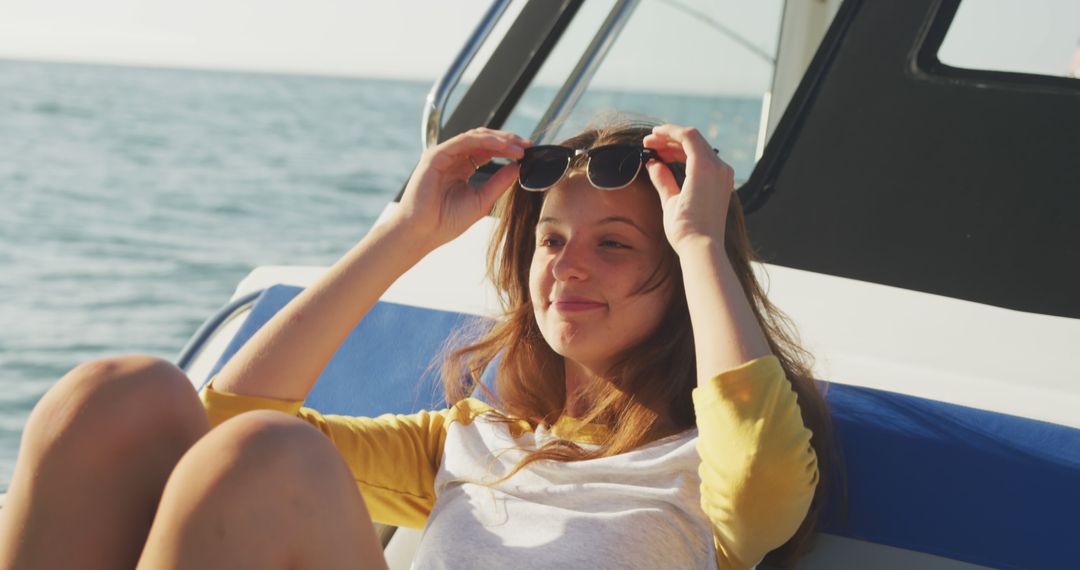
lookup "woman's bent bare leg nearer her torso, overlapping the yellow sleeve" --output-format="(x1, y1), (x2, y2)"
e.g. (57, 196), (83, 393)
(138, 411), (386, 569)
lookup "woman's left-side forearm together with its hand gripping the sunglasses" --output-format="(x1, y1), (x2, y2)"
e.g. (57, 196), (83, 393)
(207, 128), (528, 401)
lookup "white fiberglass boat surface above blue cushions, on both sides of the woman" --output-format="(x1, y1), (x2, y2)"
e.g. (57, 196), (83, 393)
(237, 204), (1080, 428)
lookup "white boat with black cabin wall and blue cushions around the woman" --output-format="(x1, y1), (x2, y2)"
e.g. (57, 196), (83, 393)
(141, 0), (1080, 570)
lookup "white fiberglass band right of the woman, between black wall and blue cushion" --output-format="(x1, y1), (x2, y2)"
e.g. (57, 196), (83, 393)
(758, 260), (1080, 428)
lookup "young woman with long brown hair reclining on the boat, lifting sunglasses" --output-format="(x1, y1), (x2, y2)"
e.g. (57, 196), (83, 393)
(0, 125), (831, 569)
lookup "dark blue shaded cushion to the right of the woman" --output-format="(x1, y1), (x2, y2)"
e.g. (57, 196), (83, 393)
(825, 383), (1080, 568)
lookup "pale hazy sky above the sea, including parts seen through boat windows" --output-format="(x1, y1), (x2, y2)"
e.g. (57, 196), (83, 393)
(0, 0), (1080, 87)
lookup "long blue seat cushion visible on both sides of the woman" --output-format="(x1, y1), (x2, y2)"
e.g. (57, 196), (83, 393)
(214, 286), (1080, 568)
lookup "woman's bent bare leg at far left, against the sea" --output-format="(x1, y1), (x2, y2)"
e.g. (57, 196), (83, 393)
(0, 356), (210, 569)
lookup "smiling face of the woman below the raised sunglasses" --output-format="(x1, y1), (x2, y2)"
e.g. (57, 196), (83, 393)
(529, 172), (672, 374)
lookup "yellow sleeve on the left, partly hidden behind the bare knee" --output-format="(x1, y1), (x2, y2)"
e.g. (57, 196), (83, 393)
(200, 379), (455, 528)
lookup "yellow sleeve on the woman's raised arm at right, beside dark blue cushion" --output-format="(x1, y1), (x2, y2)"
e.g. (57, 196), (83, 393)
(693, 354), (818, 569)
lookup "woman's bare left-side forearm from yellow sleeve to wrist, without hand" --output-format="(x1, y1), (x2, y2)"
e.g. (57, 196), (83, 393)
(214, 215), (431, 401)
